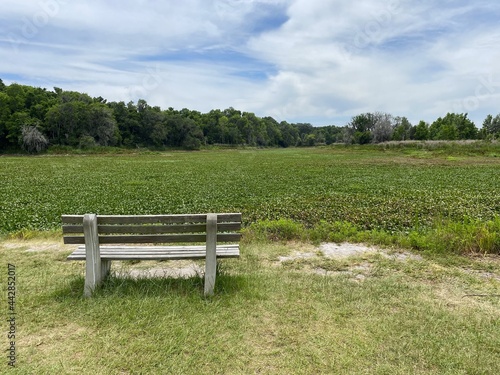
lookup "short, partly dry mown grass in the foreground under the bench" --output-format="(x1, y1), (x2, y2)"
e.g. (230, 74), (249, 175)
(0, 239), (500, 375)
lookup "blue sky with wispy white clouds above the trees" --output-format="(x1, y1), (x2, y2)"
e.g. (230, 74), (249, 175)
(0, 0), (500, 127)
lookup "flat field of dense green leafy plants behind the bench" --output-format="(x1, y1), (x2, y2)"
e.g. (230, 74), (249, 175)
(0, 146), (500, 252)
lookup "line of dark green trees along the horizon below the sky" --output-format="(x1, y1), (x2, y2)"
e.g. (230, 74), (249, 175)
(0, 79), (500, 152)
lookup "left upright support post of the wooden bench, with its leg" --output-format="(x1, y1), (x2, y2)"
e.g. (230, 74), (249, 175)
(83, 214), (103, 297)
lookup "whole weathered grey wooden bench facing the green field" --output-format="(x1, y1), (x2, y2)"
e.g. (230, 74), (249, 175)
(62, 213), (241, 297)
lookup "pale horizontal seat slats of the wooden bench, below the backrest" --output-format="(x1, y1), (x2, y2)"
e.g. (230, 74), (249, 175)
(68, 244), (240, 260)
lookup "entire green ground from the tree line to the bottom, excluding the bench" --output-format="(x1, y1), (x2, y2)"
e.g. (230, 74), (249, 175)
(0, 144), (500, 375)
